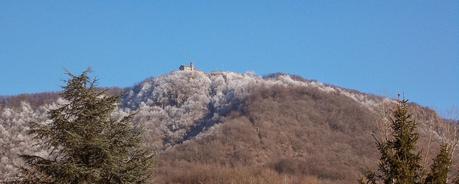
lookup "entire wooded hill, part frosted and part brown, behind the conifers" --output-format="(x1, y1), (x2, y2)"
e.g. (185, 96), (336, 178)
(0, 71), (457, 183)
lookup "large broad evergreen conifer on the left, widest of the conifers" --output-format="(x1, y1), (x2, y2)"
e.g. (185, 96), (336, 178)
(16, 70), (152, 184)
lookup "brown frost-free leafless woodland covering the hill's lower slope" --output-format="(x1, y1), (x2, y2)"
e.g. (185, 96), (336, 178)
(157, 87), (452, 183)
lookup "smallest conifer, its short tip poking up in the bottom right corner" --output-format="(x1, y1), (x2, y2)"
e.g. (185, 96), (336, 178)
(426, 144), (451, 184)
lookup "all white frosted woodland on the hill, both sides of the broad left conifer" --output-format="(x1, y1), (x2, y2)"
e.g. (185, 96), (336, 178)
(0, 71), (402, 181)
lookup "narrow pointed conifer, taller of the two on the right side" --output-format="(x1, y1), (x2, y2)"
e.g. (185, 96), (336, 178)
(360, 100), (423, 184)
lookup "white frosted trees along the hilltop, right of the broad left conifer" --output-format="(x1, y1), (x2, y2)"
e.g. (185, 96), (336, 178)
(123, 71), (376, 150)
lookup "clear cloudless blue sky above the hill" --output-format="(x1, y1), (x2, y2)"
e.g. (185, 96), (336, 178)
(0, 0), (459, 115)
